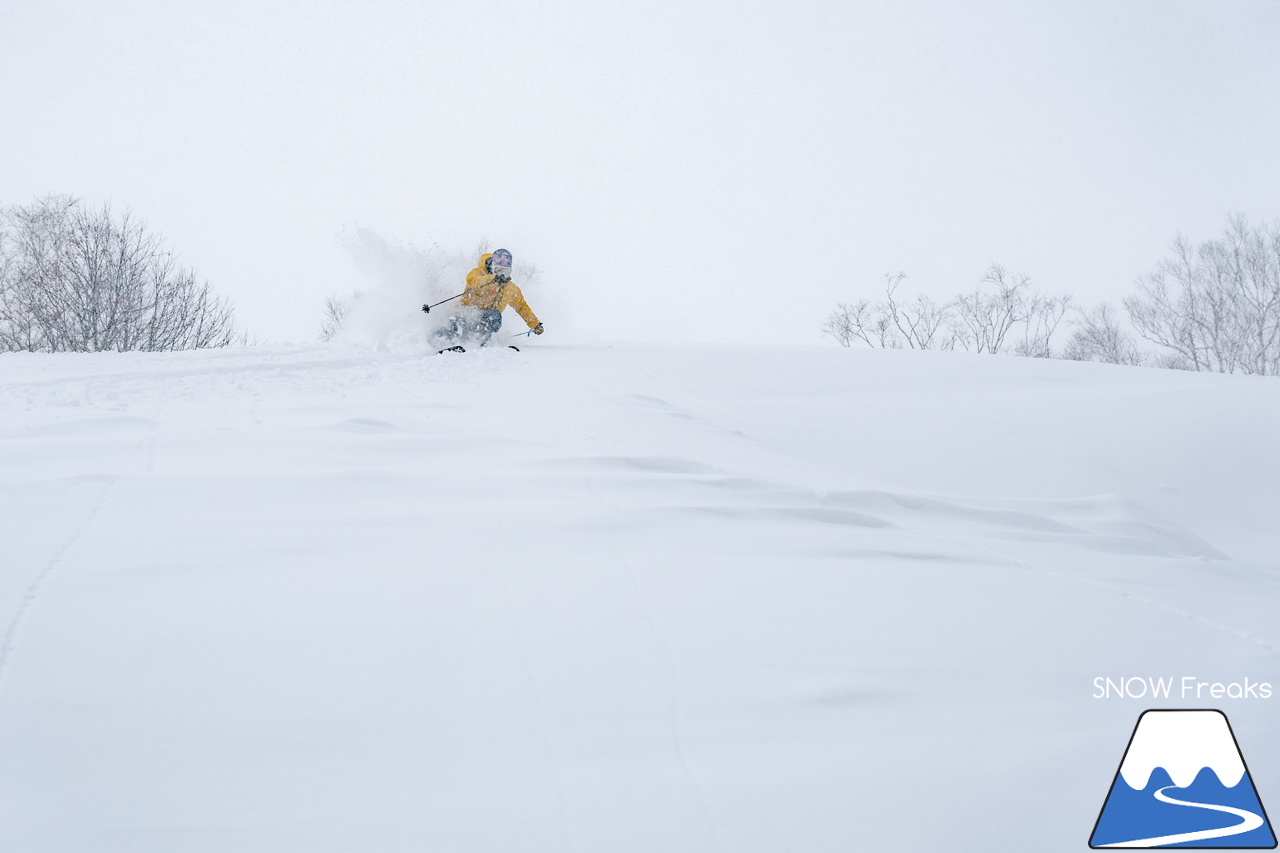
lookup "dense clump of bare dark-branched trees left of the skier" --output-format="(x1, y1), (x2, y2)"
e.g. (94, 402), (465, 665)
(0, 196), (236, 352)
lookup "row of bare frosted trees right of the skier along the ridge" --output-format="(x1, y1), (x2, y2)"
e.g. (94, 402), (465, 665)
(823, 215), (1280, 375)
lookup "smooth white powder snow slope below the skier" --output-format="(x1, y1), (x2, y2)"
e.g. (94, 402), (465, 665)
(0, 336), (1280, 853)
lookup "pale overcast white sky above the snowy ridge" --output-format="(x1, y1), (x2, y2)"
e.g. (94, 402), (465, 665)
(0, 0), (1280, 343)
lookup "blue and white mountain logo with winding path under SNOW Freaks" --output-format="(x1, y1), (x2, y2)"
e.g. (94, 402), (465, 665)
(1089, 711), (1276, 849)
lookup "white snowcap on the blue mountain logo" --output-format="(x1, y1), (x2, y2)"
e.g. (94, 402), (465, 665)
(1120, 711), (1244, 790)
